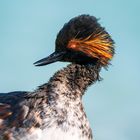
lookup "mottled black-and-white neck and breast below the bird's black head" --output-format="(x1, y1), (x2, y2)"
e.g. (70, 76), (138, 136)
(35, 64), (101, 139)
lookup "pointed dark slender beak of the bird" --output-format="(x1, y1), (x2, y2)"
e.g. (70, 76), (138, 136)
(34, 52), (65, 66)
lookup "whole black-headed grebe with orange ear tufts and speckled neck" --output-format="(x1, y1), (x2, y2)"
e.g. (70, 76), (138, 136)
(0, 15), (114, 140)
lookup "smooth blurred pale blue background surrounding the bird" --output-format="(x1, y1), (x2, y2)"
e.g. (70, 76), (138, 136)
(0, 0), (140, 140)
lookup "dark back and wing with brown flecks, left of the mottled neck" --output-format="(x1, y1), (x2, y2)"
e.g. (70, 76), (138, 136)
(0, 92), (44, 129)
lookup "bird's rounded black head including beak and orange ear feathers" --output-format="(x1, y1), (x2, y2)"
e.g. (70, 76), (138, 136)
(34, 15), (114, 67)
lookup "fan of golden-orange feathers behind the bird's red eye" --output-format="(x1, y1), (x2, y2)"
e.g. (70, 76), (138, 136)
(67, 29), (114, 66)
